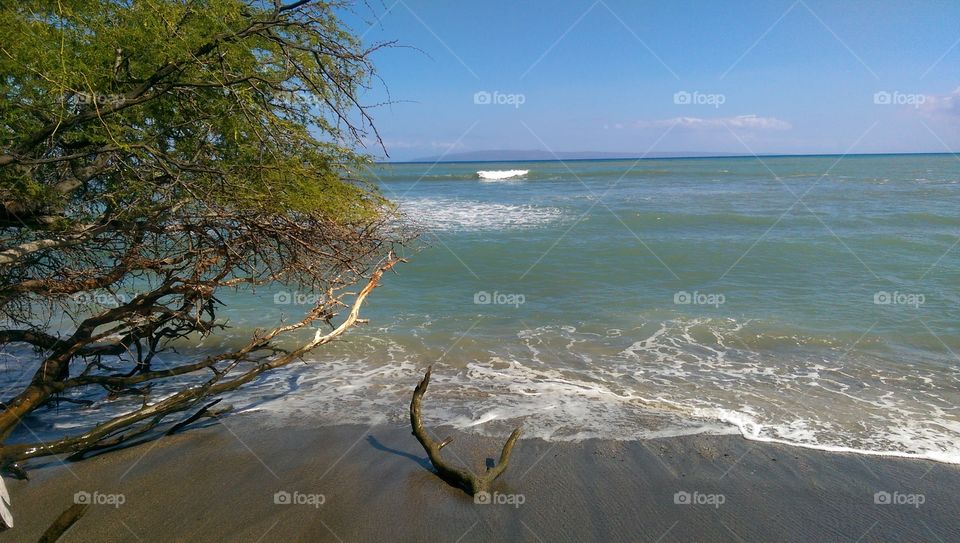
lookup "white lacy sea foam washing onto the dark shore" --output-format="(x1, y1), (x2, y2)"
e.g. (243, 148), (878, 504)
(236, 319), (960, 464)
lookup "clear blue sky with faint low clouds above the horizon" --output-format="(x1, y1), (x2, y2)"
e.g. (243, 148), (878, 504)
(344, 0), (960, 160)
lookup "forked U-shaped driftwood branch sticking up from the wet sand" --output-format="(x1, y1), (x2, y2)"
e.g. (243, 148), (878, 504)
(410, 366), (520, 496)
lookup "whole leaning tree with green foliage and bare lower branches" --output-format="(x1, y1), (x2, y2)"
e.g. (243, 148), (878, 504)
(0, 0), (407, 467)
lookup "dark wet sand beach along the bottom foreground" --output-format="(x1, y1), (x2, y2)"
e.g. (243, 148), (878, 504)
(0, 415), (960, 542)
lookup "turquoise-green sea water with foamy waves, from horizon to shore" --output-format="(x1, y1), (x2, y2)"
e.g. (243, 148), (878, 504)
(9, 155), (960, 462)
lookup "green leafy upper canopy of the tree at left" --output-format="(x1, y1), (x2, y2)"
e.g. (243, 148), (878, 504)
(0, 0), (388, 226)
